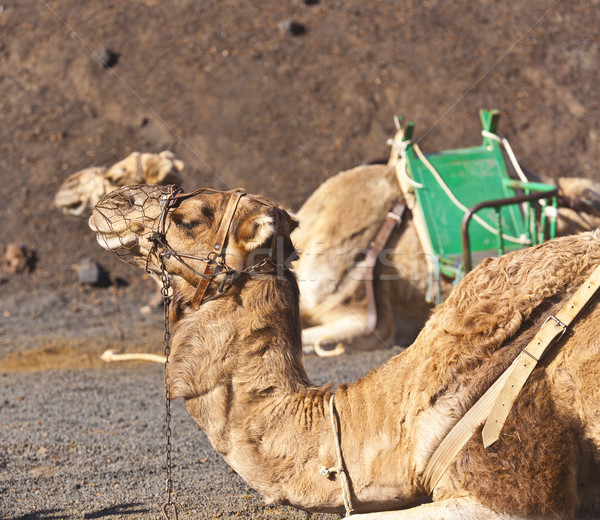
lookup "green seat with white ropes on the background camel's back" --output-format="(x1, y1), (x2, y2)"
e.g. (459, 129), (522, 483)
(391, 110), (557, 302)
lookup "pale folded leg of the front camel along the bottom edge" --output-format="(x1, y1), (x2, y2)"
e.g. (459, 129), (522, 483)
(347, 498), (522, 520)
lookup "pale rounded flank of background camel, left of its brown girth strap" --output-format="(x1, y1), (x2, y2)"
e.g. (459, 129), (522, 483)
(292, 164), (401, 321)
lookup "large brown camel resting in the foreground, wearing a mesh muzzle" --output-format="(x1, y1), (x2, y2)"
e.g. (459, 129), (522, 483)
(90, 186), (600, 520)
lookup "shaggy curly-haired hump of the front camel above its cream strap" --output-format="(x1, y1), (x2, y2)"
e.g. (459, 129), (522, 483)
(432, 229), (600, 356)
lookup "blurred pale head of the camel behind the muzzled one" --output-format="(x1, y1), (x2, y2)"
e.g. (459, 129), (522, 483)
(54, 150), (184, 215)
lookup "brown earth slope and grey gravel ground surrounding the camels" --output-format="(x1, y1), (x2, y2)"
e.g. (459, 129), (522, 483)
(0, 0), (600, 520)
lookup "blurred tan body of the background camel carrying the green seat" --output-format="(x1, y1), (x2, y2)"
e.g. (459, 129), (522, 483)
(292, 165), (600, 352)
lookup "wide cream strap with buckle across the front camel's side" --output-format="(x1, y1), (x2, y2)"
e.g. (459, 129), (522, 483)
(422, 266), (600, 493)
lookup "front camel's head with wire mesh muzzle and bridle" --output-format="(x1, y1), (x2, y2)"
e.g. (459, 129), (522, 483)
(89, 185), (297, 302)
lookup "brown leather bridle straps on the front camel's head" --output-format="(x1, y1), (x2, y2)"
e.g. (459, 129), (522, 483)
(146, 185), (289, 309)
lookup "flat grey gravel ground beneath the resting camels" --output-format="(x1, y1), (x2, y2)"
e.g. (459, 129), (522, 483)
(0, 322), (393, 520)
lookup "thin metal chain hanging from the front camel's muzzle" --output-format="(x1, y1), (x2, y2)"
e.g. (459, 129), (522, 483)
(160, 255), (177, 520)
